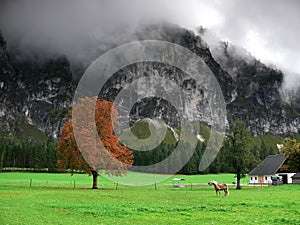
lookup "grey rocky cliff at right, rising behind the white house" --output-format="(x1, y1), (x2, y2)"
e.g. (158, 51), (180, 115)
(212, 42), (300, 135)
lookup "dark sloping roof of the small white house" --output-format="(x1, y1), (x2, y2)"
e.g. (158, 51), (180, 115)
(249, 154), (287, 175)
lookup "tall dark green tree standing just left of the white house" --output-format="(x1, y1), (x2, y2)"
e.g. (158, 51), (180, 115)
(224, 120), (254, 190)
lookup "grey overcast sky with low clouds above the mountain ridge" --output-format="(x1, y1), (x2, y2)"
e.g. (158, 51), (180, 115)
(0, 0), (300, 86)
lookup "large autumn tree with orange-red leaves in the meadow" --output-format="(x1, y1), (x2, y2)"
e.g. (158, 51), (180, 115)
(56, 97), (133, 189)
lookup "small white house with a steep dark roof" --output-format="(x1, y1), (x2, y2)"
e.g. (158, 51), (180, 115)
(249, 154), (295, 185)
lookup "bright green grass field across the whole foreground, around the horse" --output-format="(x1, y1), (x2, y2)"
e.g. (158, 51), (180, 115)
(0, 173), (300, 225)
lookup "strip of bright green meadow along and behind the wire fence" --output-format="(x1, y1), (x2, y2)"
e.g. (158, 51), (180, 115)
(0, 171), (252, 190)
